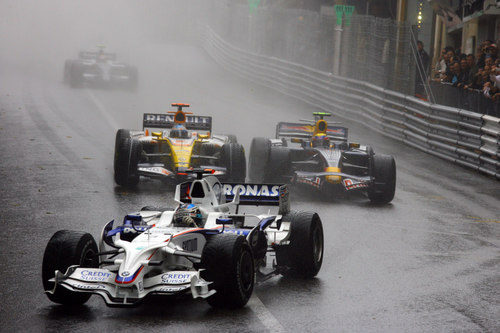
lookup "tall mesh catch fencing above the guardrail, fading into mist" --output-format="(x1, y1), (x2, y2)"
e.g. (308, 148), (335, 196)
(198, 0), (415, 94)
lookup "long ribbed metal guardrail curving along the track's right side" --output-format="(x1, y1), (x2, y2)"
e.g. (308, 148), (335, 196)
(202, 27), (500, 179)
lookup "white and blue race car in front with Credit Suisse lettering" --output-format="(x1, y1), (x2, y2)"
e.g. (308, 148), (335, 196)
(42, 169), (323, 308)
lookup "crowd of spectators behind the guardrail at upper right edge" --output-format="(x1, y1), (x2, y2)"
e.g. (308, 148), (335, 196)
(434, 40), (500, 102)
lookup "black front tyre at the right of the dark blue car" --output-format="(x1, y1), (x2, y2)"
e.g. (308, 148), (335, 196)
(368, 155), (396, 204)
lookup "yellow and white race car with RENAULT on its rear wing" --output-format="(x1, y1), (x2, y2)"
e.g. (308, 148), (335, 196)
(114, 103), (246, 186)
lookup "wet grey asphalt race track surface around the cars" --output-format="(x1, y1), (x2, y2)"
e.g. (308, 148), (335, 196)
(0, 45), (500, 332)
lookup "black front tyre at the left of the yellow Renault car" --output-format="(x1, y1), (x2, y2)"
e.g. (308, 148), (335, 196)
(114, 134), (141, 187)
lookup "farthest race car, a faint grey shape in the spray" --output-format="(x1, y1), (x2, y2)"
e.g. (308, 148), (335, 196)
(64, 48), (138, 90)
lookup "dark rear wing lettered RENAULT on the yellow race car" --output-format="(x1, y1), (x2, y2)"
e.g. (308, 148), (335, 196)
(142, 113), (212, 132)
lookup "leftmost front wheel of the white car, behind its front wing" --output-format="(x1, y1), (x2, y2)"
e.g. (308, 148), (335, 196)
(42, 230), (99, 304)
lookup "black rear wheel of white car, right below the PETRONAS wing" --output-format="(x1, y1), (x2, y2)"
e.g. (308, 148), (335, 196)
(276, 211), (324, 278)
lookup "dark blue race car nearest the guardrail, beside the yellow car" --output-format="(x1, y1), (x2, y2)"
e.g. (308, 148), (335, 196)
(249, 112), (396, 203)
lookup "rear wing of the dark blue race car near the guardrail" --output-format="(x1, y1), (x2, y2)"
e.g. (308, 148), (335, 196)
(276, 122), (348, 141)
